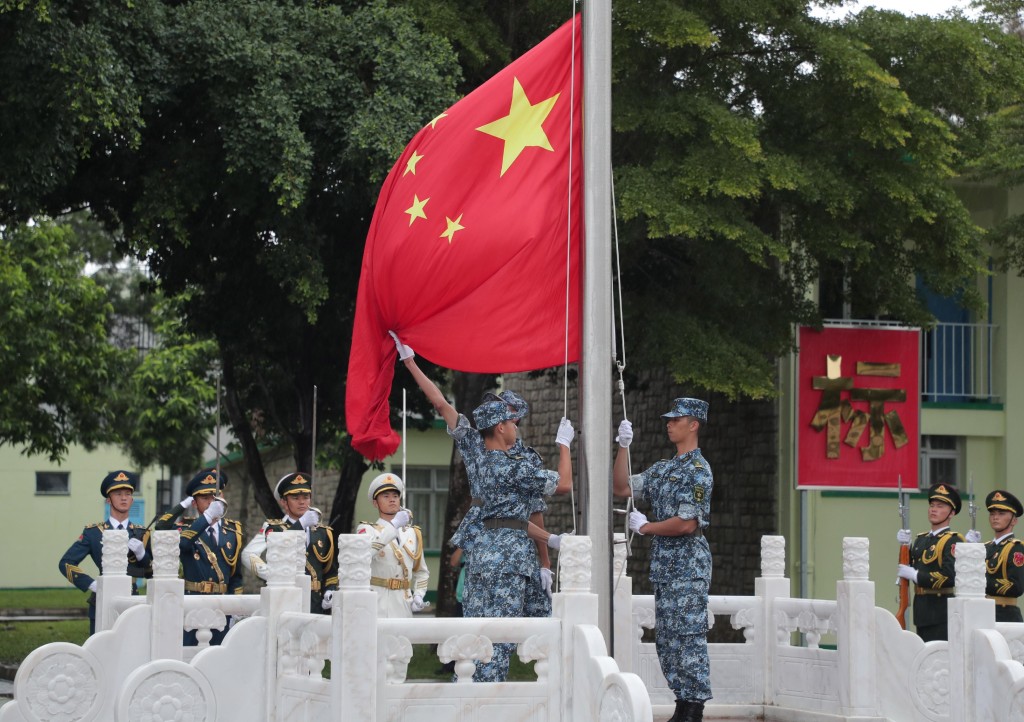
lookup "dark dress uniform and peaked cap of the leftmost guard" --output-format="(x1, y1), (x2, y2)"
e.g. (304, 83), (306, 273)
(57, 470), (153, 634)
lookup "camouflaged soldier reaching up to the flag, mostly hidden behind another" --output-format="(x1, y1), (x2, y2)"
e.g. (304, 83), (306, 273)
(391, 333), (561, 617)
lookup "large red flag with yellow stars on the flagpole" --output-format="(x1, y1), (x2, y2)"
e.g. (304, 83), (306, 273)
(345, 17), (583, 459)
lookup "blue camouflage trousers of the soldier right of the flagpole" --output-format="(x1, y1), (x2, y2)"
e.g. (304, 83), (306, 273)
(653, 580), (711, 702)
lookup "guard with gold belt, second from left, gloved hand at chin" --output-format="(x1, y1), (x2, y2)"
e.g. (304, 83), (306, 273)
(157, 469), (244, 646)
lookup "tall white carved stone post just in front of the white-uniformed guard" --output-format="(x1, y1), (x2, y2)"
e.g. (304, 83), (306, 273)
(331, 534), (378, 720)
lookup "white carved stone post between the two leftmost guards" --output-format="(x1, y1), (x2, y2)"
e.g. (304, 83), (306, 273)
(146, 529), (185, 662)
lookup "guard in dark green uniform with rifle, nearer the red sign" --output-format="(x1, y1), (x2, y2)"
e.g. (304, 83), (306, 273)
(896, 483), (964, 642)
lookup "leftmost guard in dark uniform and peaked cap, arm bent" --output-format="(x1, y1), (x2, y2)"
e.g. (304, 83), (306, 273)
(57, 471), (152, 634)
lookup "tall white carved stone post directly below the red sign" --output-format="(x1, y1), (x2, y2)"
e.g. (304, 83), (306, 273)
(836, 537), (878, 717)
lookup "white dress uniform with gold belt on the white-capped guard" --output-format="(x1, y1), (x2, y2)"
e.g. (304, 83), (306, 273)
(355, 519), (430, 618)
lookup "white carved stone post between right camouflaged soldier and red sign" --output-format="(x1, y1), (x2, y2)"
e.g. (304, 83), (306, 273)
(753, 536), (790, 705)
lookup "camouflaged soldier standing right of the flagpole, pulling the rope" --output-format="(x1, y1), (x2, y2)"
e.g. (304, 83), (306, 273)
(612, 398), (714, 722)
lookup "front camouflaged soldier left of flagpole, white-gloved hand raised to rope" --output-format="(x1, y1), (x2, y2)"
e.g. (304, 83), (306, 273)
(463, 401), (573, 682)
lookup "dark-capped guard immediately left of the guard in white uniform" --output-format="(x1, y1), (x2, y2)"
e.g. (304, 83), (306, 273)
(242, 471), (338, 614)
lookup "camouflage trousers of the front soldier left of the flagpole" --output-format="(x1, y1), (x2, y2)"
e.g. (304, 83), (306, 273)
(462, 570), (528, 682)
